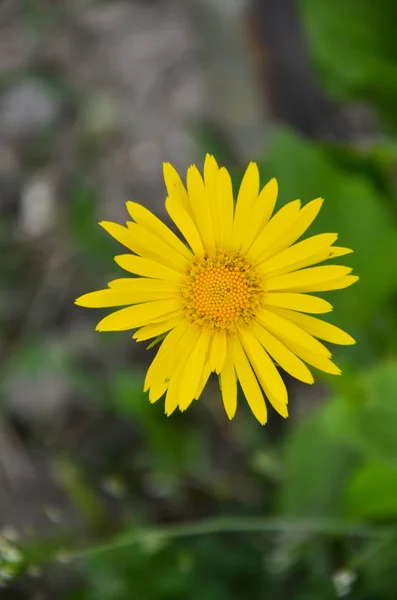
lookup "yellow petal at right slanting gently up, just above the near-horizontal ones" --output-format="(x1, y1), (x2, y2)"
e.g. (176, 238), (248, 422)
(260, 233), (338, 274)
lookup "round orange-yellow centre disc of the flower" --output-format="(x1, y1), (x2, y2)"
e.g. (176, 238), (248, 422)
(182, 251), (264, 331)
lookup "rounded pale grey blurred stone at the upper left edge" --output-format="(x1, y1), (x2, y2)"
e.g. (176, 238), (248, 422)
(0, 79), (60, 139)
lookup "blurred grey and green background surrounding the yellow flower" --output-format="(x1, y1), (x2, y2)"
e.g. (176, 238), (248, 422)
(0, 0), (397, 600)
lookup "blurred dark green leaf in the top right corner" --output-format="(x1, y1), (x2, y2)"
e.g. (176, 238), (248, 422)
(300, 0), (397, 122)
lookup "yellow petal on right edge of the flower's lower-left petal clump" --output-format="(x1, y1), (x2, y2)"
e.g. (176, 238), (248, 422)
(179, 330), (211, 411)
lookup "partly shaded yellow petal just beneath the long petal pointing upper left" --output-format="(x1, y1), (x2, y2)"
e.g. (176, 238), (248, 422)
(127, 221), (189, 272)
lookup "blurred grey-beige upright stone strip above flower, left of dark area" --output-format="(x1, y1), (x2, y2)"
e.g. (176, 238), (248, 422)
(188, 0), (270, 162)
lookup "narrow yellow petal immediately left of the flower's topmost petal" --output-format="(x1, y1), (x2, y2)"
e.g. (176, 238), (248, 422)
(187, 165), (215, 250)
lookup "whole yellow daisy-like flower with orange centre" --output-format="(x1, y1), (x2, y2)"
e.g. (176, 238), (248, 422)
(76, 155), (358, 423)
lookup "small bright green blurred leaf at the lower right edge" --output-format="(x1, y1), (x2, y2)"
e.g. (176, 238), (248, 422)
(347, 463), (397, 518)
